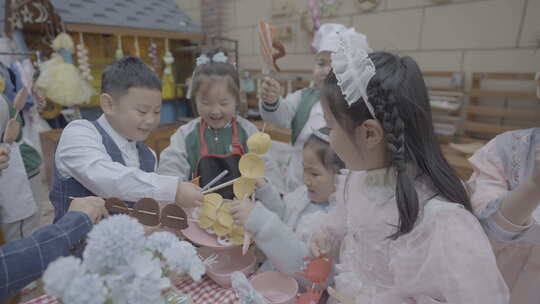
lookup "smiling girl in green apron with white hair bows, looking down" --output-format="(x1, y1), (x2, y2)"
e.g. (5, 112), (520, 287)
(158, 52), (268, 199)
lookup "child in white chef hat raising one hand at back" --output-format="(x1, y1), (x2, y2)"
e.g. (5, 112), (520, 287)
(259, 23), (371, 192)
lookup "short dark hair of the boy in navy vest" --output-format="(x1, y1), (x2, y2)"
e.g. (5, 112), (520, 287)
(101, 56), (161, 97)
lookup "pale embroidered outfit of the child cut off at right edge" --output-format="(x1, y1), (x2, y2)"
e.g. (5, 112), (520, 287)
(468, 128), (540, 304)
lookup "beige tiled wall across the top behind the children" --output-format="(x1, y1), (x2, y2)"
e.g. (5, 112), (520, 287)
(177, 0), (540, 76)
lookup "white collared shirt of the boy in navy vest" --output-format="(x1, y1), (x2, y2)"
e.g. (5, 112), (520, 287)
(55, 115), (178, 202)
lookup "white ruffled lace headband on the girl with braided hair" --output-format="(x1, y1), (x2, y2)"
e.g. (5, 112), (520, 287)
(332, 29), (375, 118)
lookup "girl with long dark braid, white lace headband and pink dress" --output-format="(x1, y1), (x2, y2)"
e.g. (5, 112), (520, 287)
(310, 30), (509, 304)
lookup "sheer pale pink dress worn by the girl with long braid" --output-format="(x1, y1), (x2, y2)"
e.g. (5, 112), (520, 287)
(320, 169), (509, 304)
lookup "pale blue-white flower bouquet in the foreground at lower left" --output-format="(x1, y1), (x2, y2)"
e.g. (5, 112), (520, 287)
(43, 215), (212, 304)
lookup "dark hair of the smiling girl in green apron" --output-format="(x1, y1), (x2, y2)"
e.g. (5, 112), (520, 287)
(191, 50), (240, 102)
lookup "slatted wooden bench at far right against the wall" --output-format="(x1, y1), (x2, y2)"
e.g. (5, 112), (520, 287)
(443, 73), (540, 180)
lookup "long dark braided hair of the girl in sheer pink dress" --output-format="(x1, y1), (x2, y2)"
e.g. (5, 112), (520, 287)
(321, 52), (472, 239)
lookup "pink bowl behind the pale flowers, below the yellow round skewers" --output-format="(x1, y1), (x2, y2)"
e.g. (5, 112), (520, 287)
(198, 247), (256, 288)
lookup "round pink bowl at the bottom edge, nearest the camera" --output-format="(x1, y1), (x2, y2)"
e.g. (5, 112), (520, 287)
(251, 272), (298, 304)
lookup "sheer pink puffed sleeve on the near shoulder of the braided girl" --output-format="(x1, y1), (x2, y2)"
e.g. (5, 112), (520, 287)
(374, 201), (509, 304)
